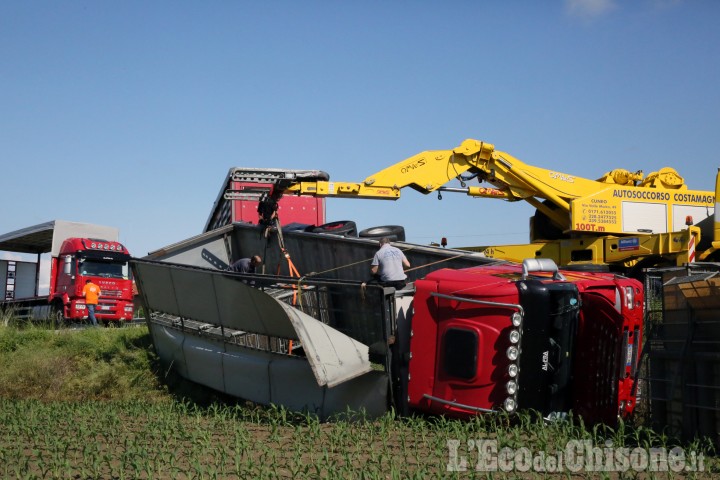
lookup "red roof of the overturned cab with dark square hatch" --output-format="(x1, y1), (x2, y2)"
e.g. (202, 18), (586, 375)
(408, 280), (517, 416)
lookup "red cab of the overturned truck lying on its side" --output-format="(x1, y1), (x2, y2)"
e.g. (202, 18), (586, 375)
(403, 259), (643, 424)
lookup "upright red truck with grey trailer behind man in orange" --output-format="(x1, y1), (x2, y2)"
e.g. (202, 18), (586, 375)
(0, 220), (134, 325)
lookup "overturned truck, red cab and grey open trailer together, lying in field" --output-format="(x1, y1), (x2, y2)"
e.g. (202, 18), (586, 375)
(133, 223), (643, 423)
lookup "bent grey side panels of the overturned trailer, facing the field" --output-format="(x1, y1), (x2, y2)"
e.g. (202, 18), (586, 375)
(132, 259), (388, 417)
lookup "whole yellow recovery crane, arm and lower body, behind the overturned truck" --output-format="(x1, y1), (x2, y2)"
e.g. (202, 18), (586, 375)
(250, 139), (720, 272)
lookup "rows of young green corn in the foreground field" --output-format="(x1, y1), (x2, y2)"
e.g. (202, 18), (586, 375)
(0, 400), (717, 479)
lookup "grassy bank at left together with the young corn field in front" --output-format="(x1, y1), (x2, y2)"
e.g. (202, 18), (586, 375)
(0, 319), (720, 479)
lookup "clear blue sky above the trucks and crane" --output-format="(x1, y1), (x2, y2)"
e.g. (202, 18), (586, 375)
(0, 0), (720, 256)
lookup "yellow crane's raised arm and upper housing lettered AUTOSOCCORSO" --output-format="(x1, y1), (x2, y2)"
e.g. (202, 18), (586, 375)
(250, 139), (715, 244)
